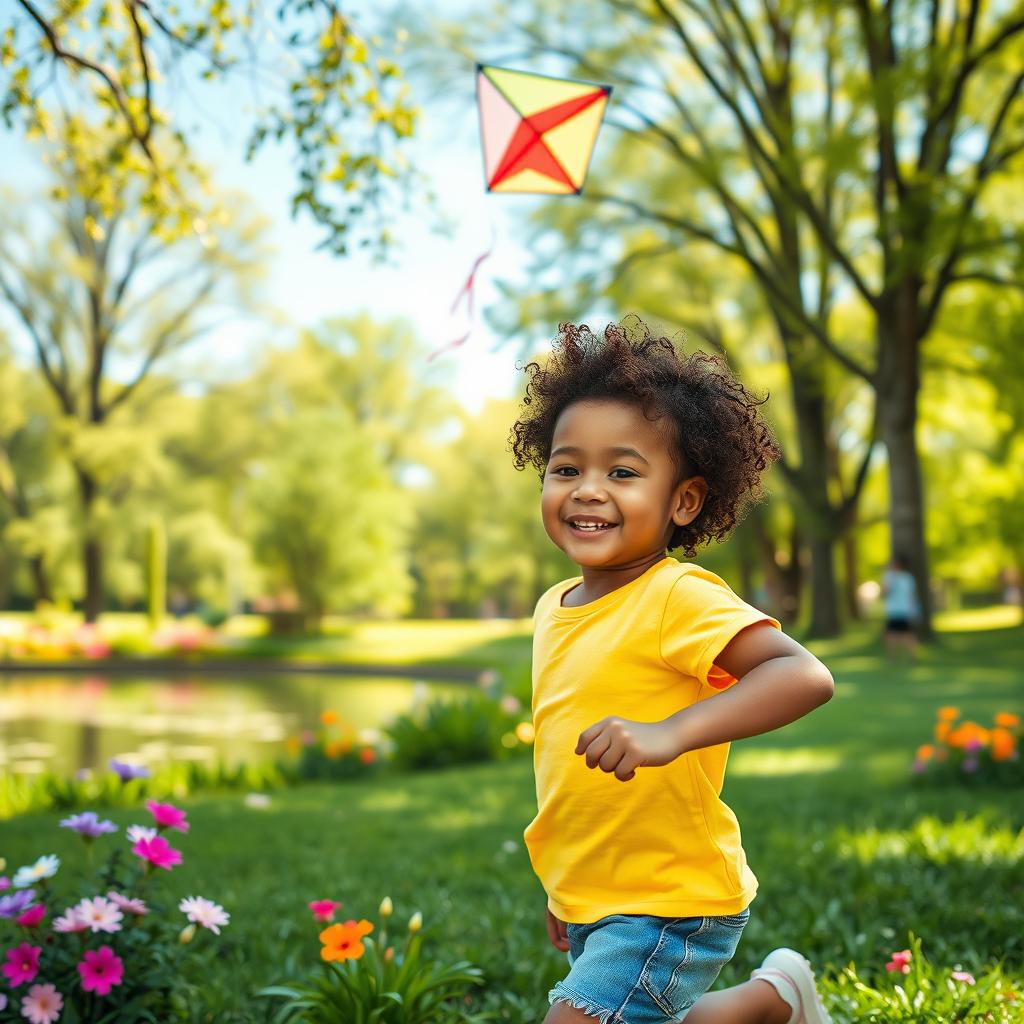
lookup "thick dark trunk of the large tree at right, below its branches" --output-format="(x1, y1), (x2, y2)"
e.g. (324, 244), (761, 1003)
(878, 296), (932, 638)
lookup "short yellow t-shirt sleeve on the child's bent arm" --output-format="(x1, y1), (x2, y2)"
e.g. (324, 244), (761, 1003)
(659, 565), (780, 689)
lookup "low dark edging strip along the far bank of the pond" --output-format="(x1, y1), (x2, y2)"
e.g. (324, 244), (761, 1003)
(0, 657), (483, 682)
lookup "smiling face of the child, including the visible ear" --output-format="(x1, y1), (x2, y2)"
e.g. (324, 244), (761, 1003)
(541, 399), (708, 568)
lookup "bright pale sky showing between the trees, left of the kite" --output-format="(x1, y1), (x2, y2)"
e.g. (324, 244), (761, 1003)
(0, 9), (561, 413)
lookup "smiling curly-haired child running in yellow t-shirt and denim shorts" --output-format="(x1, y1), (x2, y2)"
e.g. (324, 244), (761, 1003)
(510, 322), (834, 1024)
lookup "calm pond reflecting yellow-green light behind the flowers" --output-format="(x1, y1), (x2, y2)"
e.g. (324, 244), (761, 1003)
(0, 672), (474, 775)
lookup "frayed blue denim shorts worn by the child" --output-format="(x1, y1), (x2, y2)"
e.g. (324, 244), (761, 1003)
(548, 909), (751, 1024)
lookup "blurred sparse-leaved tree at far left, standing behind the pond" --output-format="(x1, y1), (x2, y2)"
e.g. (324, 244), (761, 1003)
(0, 130), (268, 622)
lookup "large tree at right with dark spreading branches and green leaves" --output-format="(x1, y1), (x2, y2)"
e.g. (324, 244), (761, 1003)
(438, 0), (1024, 627)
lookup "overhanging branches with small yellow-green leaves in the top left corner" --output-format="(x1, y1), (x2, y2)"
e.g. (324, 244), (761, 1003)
(0, 0), (417, 253)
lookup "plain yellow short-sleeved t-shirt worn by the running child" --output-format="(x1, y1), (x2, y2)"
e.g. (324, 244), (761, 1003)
(524, 556), (779, 924)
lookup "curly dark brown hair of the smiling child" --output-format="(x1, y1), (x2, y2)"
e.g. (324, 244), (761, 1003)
(509, 316), (780, 556)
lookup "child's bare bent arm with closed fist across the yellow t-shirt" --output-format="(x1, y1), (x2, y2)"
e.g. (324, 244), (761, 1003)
(575, 623), (836, 782)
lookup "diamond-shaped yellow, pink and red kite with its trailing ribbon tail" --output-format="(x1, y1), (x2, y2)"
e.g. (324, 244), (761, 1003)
(427, 65), (611, 362)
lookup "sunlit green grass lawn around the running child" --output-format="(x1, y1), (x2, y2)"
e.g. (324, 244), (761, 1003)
(0, 622), (1024, 1024)
